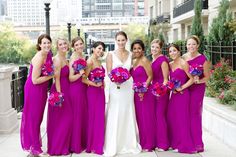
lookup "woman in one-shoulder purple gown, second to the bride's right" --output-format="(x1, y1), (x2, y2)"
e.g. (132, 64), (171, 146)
(151, 39), (169, 151)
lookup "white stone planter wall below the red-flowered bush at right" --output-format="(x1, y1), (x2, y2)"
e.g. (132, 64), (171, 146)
(202, 97), (236, 150)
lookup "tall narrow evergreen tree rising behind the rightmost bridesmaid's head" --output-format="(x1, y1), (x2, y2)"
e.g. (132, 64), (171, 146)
(191, 0), (204, 52)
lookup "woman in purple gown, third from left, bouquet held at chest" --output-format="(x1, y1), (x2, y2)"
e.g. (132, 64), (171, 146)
(69, 37), (88, 153)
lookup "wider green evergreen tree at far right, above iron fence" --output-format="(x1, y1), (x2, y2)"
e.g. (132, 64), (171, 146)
(208, 0), (234, 44)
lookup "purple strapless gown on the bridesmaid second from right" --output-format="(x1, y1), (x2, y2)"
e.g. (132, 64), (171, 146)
(167, 68), (196, 153)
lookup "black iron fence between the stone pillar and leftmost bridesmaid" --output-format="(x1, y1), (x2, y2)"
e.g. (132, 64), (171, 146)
(11, 66), (28, 112)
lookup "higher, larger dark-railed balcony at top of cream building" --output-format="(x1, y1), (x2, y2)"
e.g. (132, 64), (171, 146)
(173, 0), (208, 18)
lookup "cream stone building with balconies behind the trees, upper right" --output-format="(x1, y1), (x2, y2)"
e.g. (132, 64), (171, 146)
(148, 0), (236, 42)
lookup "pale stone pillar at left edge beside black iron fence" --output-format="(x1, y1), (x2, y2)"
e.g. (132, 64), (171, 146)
(0, 67), (18, 134)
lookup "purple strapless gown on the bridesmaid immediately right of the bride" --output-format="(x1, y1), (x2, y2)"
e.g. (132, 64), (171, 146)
(131, 66), (156, 151)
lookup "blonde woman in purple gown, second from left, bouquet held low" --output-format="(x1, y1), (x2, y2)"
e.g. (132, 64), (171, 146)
(47, 39), (73, 155)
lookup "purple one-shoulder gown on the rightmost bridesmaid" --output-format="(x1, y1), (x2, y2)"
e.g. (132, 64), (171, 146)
(188, 55), (207, 152)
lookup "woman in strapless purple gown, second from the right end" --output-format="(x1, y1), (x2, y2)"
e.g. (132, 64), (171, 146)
(167, 44), (196, 153)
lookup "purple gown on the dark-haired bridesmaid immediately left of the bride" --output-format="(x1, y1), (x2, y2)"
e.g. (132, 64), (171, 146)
(86, 67), (105, 154)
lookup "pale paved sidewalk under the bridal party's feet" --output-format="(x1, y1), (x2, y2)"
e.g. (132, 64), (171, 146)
(0, 111), (236, 157)
